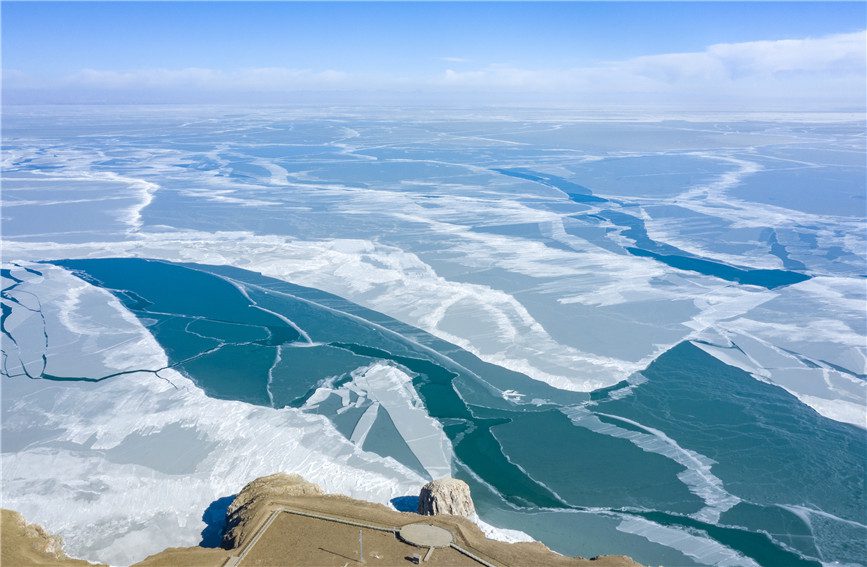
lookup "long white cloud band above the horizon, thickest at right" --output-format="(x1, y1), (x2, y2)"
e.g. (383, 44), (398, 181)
(4, 31), (867, 108)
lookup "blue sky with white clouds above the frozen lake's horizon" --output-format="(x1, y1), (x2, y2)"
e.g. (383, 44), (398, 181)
(0, 2), (867, 110)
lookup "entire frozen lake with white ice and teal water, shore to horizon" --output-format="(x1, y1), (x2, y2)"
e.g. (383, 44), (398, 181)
(0, 107), (867, 565)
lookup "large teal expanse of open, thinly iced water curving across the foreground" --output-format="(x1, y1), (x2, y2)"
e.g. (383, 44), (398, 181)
(49, 259), (867, 565)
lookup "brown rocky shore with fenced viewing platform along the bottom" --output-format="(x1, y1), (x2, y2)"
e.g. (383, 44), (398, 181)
(2, 473), (638, 567)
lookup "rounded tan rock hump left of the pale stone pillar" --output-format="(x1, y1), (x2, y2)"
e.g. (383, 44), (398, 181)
(223, 473), (322, 549)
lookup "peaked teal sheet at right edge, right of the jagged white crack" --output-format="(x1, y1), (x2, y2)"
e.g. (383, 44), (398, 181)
(599, 344), (867, 562)
